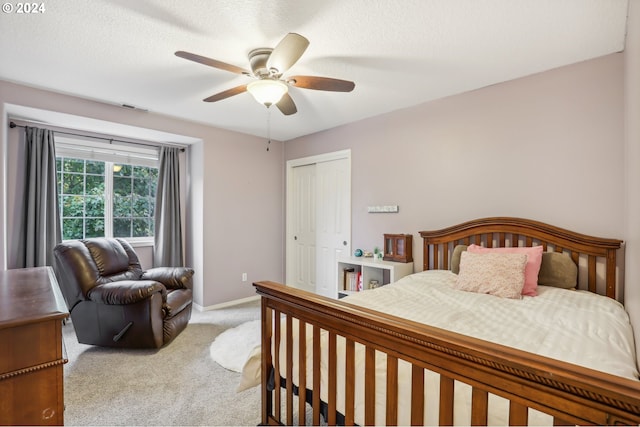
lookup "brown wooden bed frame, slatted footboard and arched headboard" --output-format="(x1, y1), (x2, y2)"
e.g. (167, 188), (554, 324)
(254, 217), (640, 425)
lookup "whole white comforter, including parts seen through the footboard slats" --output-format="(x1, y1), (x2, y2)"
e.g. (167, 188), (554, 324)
(262, 270), (638, 425)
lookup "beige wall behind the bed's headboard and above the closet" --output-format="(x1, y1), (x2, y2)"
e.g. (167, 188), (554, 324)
(285, 54), (625, 270)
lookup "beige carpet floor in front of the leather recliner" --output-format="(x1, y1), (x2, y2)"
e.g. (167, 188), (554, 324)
(63, 301), (260, 426)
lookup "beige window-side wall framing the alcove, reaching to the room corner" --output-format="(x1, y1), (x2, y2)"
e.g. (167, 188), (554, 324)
(0, 81), (284, 307)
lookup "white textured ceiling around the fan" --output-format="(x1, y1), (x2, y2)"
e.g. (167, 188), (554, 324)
(0, 0), (638, 141)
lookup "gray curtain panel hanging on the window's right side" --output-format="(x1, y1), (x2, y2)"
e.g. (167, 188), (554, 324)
(153, 147), (184, 267)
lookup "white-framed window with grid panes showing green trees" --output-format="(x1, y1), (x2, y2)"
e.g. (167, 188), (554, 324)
(56, 137), (158, 240)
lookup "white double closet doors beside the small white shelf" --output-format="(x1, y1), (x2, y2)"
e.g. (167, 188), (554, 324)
(286, 151), (351, 298)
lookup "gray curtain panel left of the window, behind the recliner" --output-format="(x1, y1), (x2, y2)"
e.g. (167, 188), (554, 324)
(17, 126), (62, 267)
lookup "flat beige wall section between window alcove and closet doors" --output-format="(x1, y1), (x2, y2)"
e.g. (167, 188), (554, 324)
(200, 121), (284, 306)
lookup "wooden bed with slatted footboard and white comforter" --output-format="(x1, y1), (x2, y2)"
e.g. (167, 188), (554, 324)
(254, 217), (640, 425)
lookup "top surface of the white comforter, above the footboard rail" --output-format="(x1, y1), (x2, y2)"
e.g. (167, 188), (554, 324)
(343, 270), (638, 379)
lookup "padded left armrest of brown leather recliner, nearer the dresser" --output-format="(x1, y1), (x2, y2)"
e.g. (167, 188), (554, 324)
(87, 280), (167, 305)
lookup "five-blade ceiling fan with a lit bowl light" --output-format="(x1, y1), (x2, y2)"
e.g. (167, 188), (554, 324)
(175, 33), (355, 116)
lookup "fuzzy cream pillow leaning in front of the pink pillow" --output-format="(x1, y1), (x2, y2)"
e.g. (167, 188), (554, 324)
(453, 251), (527, 299)
